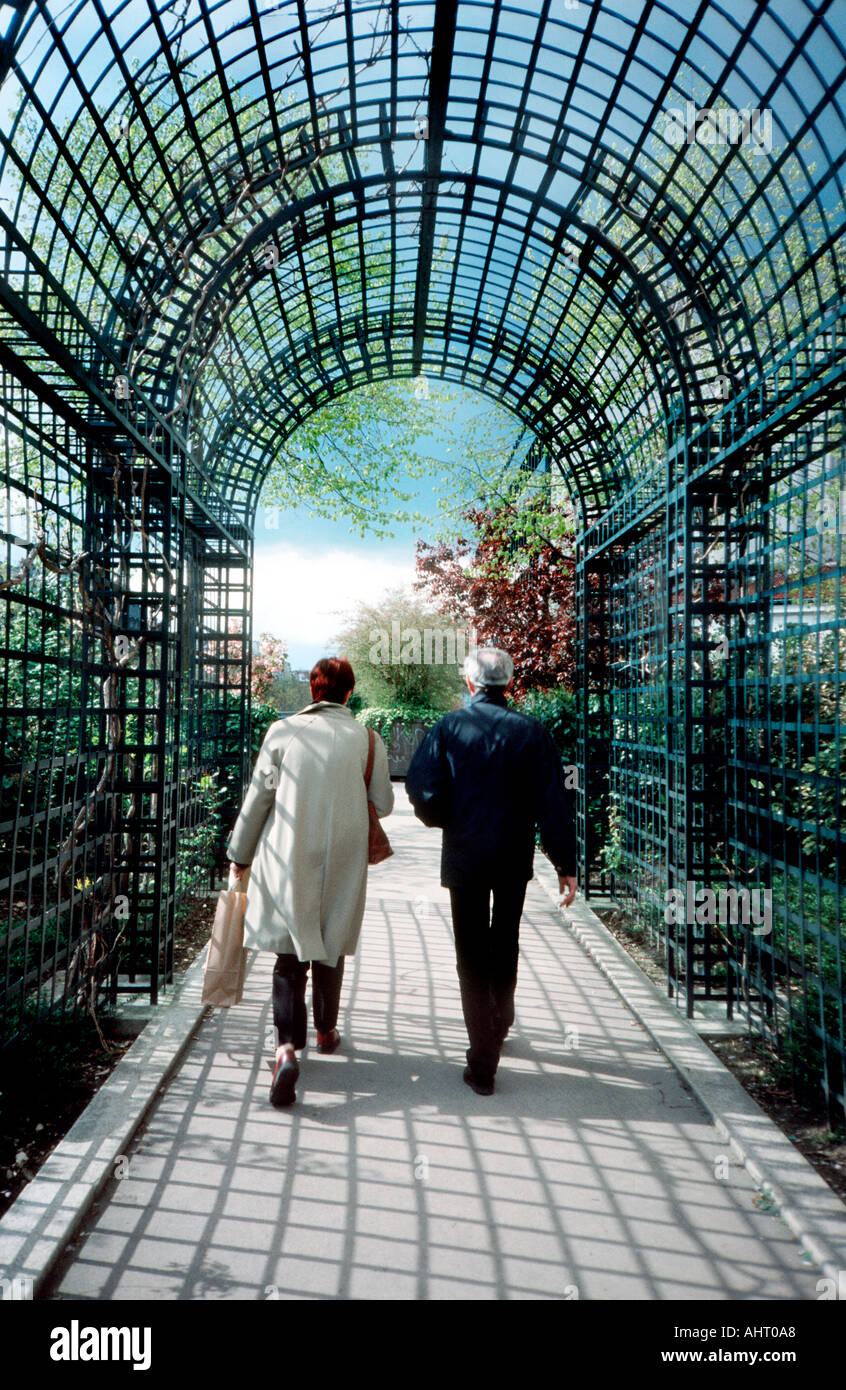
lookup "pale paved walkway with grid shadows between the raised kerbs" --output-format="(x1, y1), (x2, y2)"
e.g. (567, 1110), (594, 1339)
(44, 787), (820, 1300)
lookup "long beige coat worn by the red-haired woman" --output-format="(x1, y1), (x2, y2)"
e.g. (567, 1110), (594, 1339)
(228, 701), (393, 965)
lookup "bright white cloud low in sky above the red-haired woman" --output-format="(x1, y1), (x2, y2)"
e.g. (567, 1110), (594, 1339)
(253, 542), (415, 667)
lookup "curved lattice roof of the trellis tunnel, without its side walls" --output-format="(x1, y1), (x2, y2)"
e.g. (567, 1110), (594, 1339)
(0, 0), (846, 518)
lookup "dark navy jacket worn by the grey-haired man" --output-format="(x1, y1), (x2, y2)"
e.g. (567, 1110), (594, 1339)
(406, 691), (577, 888)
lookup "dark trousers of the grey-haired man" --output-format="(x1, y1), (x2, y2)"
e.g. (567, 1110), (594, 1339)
(450, 883), (526, 1081)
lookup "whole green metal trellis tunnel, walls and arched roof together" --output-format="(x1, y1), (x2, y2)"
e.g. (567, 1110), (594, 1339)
(0, 0), (846, 1111)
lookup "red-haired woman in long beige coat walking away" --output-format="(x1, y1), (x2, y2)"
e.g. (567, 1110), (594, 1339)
(228, 656), (393, 1105)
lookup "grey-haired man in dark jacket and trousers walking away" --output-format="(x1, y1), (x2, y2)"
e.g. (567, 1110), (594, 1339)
(406, 646), (577, 1095)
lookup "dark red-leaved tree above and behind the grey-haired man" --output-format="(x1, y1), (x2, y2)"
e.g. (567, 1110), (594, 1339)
(417, 500), (575, 696)
